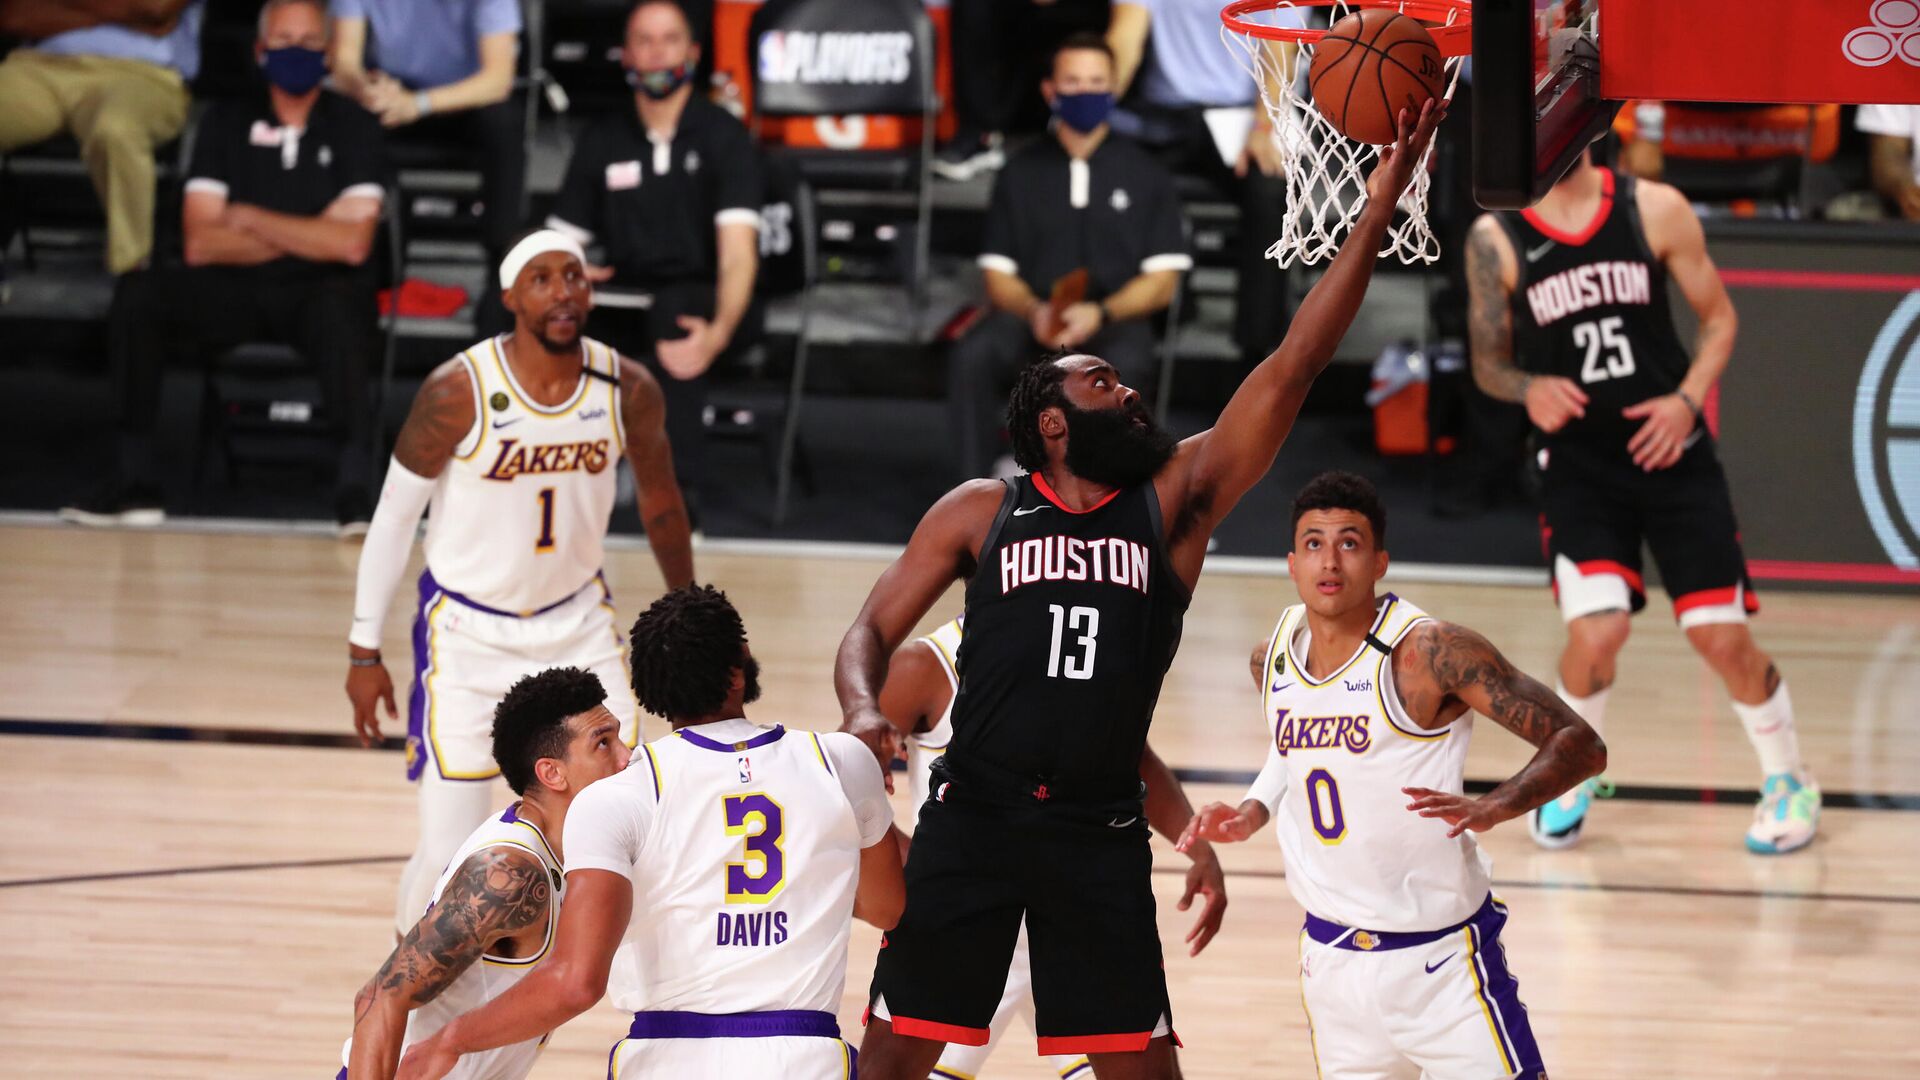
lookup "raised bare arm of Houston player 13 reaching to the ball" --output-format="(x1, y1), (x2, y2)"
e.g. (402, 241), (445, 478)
(1173, 98), (1446, 545)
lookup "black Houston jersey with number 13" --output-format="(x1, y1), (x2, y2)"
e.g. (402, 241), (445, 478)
(947, 475), (1188, 790)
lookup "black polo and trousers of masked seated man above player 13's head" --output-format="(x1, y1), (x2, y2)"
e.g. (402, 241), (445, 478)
(944, 135), (1192, 477)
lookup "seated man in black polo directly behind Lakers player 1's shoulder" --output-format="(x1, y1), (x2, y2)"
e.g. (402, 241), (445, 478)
(547, 0), (764, 511)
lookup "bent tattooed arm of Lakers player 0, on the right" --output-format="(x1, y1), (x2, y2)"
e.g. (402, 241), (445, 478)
(1394, 623), (1607, 836)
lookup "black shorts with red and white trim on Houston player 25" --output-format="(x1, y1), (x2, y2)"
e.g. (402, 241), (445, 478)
(1540, 436), (1761, 625)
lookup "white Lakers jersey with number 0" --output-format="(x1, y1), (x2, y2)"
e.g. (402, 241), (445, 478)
(1261, 594), (1490, 932)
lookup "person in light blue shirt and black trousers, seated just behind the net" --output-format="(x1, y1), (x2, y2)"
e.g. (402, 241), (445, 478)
(1106, 0), (1306, 359)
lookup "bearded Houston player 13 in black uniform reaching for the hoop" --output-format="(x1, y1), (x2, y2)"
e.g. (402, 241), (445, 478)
(833, 102), (1444, 1080)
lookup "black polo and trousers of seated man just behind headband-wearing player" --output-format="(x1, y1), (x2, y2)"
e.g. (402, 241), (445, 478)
(547, 94), (766, 498)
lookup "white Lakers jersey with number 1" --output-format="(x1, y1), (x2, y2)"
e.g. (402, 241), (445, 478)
(426, 338), (626, 615)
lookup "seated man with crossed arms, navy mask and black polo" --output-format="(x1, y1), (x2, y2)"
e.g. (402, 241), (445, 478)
(61, 0), (384, 534)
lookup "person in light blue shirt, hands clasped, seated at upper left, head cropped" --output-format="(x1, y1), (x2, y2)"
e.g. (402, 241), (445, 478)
(330, 0), (526, 334)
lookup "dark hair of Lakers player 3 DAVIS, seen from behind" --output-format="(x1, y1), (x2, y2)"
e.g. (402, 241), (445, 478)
(628, 584), (747, 719)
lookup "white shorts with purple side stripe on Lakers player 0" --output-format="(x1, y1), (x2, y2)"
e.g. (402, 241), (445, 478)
(1300, 897), (1546, 1080)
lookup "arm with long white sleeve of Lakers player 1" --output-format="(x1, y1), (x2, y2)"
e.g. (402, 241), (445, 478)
(348, 359), (478, 746)
